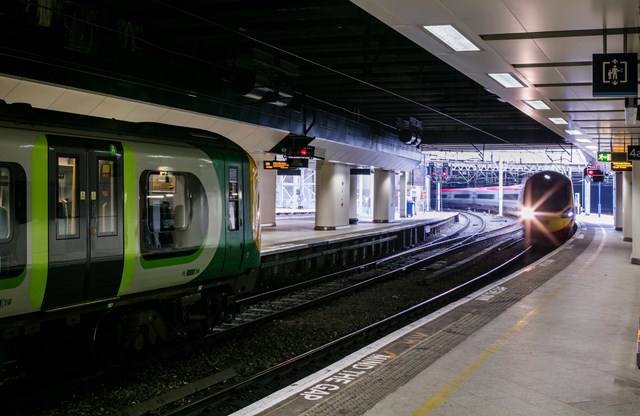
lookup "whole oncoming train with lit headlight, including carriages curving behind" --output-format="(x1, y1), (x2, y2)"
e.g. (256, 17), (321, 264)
(442, 171), (576, 245)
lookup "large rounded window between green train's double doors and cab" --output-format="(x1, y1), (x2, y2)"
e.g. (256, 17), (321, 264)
(141, 171), (209, 259)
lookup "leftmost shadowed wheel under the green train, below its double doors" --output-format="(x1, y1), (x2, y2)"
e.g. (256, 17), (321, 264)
(92, 311), (129, 366)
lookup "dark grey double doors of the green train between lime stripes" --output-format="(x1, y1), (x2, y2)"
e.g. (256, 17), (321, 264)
(43, 136), (124, 308)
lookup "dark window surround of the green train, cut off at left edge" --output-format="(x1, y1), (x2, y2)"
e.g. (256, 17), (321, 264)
(0, 162), (27, 281)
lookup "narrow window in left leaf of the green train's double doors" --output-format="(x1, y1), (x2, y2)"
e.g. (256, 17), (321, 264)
(56, 156), (79, 239)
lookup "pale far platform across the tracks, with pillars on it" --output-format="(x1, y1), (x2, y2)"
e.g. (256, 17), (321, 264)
(260, 212), (458, 256)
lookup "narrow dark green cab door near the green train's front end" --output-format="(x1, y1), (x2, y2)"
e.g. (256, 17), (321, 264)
(224, 155), (245, 273)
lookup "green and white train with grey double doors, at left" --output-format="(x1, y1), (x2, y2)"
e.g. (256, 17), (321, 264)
(0, 100), (260, 368)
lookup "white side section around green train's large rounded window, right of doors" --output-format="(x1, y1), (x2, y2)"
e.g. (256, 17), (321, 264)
(119, 142), (225, 295)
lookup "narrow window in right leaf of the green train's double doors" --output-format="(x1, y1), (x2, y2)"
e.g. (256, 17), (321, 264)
(97, 159), (118, 237)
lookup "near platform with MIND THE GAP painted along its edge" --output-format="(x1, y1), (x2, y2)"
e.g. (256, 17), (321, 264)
(233, 216), (640, 416)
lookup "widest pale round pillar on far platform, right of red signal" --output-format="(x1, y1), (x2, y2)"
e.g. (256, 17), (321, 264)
(315, 162), (351, 230)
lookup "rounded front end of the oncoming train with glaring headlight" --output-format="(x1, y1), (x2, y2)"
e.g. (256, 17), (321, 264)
(520, 171), (576, 245)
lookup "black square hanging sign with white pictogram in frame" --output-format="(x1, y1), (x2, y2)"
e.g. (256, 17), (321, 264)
(593, 53), (638, 97)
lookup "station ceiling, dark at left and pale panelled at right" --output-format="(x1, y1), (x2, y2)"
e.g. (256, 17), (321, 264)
(0, 0), (640, 162)
